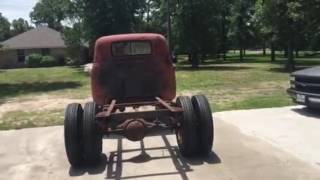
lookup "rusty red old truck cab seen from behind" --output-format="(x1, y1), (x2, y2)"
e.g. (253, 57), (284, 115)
(91, 34), (176, 105)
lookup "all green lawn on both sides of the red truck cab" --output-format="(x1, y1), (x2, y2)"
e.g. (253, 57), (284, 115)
(0, 52), (320, 129)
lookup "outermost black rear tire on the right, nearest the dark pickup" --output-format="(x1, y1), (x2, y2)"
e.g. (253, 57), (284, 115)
(191, 95), (214, 155)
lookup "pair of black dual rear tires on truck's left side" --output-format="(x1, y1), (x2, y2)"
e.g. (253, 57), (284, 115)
(64, 102), (102, 167)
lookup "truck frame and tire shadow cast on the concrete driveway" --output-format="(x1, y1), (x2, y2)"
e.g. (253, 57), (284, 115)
(69, 134), (221, 180)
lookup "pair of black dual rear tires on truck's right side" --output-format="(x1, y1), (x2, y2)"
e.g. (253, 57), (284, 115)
(176, 95), (214, 157)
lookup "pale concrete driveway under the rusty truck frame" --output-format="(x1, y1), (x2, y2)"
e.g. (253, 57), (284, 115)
(0, 107), (320, 180)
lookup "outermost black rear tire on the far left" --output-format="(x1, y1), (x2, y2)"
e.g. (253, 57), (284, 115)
(64, 104), (83, 167)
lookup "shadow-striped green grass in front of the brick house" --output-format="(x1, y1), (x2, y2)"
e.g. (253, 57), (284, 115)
(0, 67), (90, 103)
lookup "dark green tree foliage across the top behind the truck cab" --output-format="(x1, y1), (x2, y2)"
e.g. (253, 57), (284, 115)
(25, 0), (320, 70)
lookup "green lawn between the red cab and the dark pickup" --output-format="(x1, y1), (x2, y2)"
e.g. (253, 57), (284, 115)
(177, 51), (320, 111)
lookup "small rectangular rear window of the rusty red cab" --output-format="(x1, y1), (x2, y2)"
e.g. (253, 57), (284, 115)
(112, 41), (151, 56)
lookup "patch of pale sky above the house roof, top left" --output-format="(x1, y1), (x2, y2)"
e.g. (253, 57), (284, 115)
(0, 0), (38, 23)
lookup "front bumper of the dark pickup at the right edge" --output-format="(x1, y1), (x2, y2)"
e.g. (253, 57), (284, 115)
(287, 88), (320, 108)
